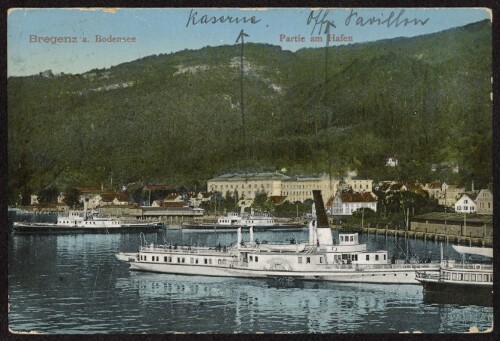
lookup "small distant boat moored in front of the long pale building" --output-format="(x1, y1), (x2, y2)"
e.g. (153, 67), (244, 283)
(182, 212), (305, 231)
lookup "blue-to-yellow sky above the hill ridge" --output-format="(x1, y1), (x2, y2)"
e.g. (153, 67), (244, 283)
(7, 8), (491, 76)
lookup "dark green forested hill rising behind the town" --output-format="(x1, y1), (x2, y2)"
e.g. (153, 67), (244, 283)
(8, 21), (492, 202)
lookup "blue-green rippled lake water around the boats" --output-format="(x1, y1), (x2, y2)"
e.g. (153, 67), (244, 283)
(8, 229), (493, 334)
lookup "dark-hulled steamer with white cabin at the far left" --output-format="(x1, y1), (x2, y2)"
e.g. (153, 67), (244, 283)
(13, 211), (164, 234)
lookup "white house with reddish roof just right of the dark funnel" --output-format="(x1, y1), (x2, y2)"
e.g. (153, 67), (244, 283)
(329, 192), (377, 215)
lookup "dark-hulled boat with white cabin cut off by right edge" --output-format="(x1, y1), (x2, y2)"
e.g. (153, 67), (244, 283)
(416, 245), (493, 301)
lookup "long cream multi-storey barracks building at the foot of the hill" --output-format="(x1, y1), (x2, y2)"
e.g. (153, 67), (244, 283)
(207, 173), (373, 203)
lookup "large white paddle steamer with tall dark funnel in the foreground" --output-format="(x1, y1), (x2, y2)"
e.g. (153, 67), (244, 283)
(116, 221), (438, 284)
